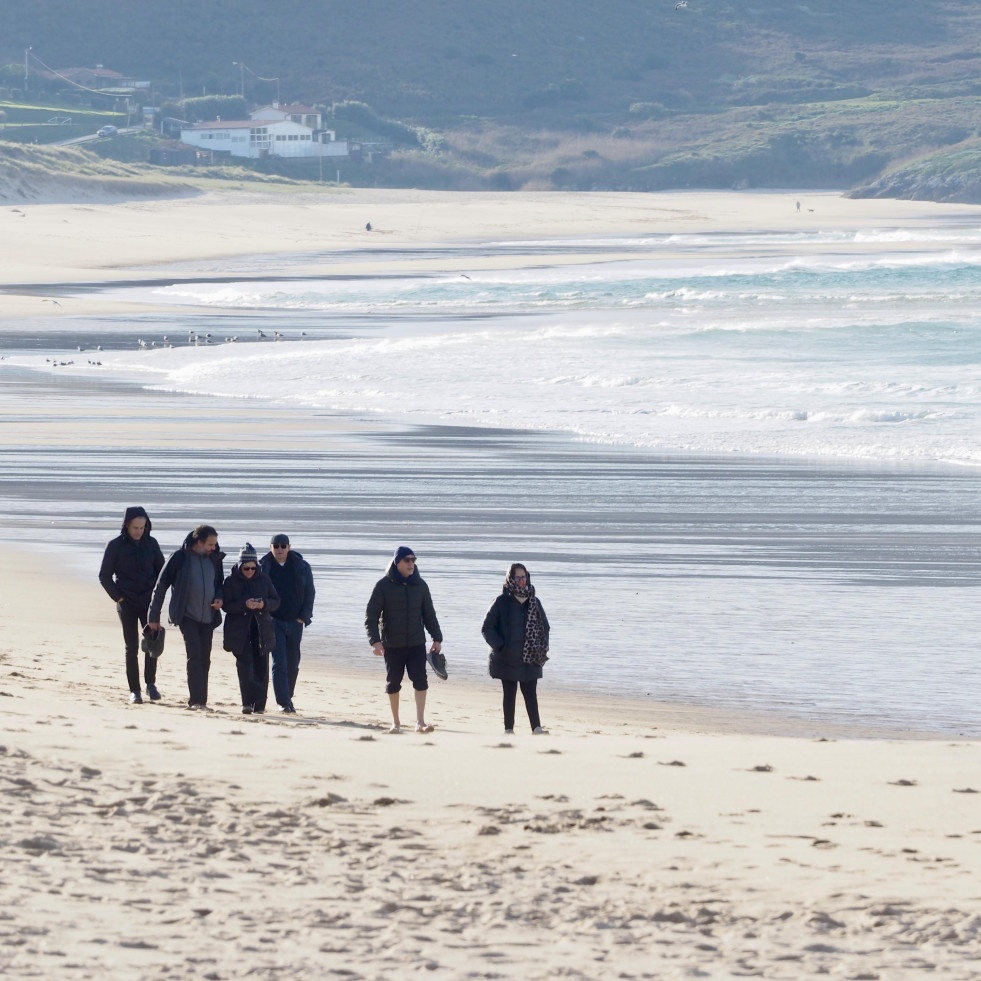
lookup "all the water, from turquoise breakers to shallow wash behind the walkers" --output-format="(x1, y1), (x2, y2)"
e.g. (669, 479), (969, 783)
(0, 222), (981, 735)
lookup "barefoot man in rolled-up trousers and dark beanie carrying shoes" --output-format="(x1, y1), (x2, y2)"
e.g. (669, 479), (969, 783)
(364, 545), (443, 732)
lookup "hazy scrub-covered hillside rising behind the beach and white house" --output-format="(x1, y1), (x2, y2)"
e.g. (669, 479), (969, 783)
(0, 0), (981, 201)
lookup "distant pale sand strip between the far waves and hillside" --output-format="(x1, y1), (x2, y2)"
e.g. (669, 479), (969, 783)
(0, 189), (981, 319)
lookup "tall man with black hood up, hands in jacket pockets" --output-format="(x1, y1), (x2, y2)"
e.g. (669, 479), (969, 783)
(99, 507), (164, 705)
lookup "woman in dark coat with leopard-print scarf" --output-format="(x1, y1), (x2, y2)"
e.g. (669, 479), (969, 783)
(480, 562), (549, 736)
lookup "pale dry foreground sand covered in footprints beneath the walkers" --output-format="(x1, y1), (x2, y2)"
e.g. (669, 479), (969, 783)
(0, 560), (981, 981)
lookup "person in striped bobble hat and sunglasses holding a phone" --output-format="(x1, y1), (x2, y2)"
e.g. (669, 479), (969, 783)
(222, 542), (279, 715)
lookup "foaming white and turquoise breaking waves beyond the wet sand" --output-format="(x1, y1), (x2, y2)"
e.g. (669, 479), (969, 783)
(53, 228), (981, 465)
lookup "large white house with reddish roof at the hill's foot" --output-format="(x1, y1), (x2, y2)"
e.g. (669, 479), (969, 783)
(181, 105), (348, 159)
